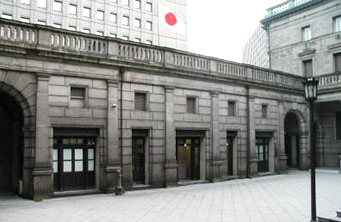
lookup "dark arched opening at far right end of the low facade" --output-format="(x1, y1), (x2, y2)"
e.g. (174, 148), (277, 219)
(284, 108), (309, 170)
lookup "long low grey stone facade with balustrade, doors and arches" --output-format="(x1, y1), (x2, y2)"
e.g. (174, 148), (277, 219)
(0, 19), (326, 199)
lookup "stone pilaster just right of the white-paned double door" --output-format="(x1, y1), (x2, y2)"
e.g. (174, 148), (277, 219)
(105, 80), (121, 193)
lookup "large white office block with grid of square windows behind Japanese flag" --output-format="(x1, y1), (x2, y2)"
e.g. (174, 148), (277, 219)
(0, 0), (187, 50)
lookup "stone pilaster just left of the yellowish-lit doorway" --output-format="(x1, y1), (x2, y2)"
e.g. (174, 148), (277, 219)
(165, 86), (178, 186)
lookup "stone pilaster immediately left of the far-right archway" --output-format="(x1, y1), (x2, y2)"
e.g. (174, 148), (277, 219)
(276, 101), (288, 173)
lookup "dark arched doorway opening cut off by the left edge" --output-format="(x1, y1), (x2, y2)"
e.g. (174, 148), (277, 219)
(0, 89), (23, 196)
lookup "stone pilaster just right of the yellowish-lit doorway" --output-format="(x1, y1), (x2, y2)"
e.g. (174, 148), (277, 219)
(211, 92), (222, 181)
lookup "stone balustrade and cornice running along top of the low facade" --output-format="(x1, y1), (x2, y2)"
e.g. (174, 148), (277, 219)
(0, 19), (303, 94)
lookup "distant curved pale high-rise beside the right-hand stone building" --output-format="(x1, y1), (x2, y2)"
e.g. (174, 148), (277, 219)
(242, 24), (269, 68)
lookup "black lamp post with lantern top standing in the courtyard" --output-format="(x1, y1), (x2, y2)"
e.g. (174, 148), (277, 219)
(302, 78), (319, 222)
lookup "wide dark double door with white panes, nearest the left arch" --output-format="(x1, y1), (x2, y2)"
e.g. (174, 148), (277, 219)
(53, 137), (96, 191)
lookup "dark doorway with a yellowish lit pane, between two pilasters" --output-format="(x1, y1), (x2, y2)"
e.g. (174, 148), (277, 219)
(176, 137), (200, 180)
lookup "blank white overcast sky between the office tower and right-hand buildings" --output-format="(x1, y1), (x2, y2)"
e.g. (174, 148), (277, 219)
(187, 0), (285, 62)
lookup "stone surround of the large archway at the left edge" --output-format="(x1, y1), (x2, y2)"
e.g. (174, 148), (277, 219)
(0, 70), (37, 197)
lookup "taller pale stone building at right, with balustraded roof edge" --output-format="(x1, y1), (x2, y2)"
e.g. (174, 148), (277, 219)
(261, 0), (341, 167)
